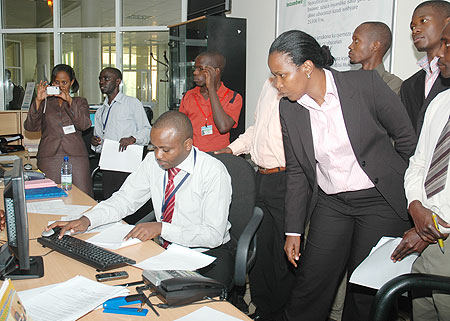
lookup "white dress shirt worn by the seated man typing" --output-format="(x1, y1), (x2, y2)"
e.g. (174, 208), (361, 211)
(85, 147), (231, 249)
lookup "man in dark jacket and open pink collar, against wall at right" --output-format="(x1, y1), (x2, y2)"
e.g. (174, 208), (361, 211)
(400, 0), (450, 135)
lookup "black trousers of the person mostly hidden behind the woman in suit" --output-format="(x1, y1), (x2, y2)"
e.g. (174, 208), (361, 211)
(249, 172), (295, 320)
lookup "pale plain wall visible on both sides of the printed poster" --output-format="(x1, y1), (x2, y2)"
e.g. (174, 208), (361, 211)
(232, 0), (423, 127)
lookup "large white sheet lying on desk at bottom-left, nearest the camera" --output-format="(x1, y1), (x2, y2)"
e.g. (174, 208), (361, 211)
(22, 276), (128, 321)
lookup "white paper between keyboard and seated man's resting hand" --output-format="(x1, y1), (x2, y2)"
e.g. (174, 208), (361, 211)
(86, 224), (142, 250)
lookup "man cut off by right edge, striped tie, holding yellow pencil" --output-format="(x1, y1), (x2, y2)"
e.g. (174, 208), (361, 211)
(391, 24), (450, 321)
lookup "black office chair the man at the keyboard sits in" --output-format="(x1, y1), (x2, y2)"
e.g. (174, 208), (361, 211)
(210, 153), (263, 304)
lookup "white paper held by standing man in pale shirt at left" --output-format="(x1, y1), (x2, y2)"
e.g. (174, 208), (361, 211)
(98, 139), (144, 173)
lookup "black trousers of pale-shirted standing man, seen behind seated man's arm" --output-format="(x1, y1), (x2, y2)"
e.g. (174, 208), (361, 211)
(102, 170), (153, 225)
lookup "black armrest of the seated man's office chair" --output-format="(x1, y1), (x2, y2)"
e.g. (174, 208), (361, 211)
(234, 207), (264, 286)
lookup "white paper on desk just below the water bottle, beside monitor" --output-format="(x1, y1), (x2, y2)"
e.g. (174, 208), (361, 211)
(27, 199), (92, 217)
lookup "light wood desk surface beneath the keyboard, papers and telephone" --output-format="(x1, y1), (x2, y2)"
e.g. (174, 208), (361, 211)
(13, 186), (250, 321)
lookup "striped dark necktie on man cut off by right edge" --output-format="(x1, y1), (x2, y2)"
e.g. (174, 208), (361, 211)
(425, 119), (450, 198)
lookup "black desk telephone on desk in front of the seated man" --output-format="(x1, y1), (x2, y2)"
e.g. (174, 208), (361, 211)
(142, 270), (227, 306)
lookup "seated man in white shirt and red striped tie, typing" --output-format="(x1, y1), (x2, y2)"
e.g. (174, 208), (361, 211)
(50, 111), (234, 286)
